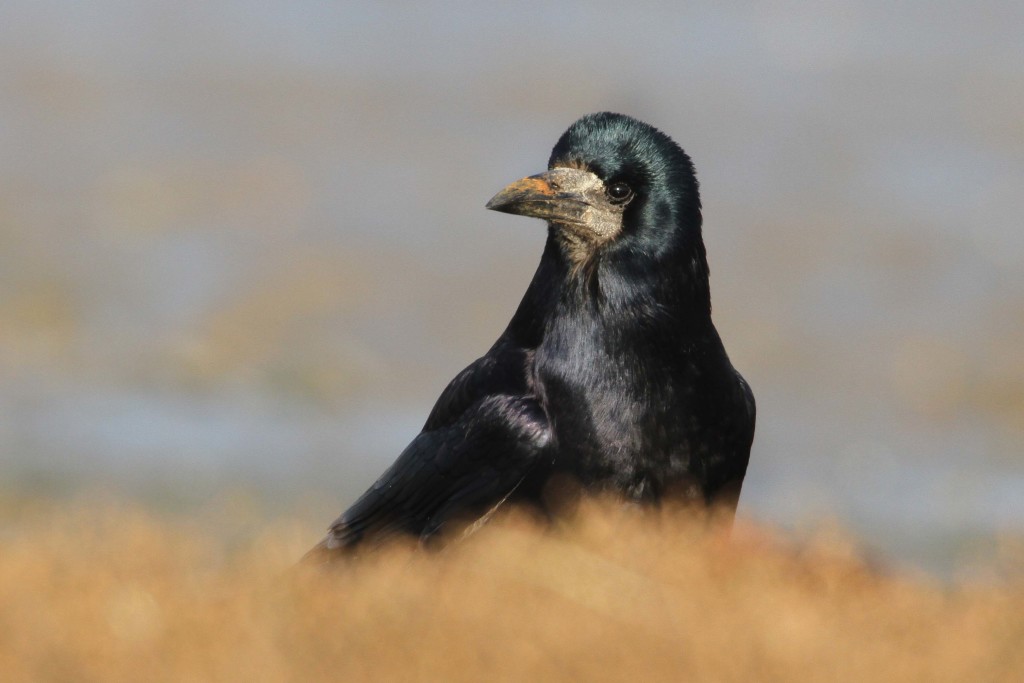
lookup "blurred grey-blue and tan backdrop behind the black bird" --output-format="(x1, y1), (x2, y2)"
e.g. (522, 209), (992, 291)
(0, 0), (1024, 575)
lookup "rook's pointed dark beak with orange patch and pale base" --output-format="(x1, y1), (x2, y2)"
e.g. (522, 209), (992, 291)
(487, 168), (600, 223)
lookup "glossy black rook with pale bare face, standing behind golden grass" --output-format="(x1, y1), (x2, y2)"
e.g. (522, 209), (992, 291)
(309, 113), (755, 559)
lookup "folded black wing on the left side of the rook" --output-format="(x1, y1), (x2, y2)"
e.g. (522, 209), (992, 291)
(311, 340), (551, 554)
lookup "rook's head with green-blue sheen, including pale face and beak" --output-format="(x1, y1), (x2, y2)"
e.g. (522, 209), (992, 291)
(487, 113), (707, 280)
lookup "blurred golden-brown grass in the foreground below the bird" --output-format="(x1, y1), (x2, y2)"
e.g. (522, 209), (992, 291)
(0, 503), (1024, 682)
